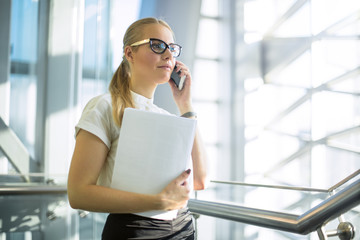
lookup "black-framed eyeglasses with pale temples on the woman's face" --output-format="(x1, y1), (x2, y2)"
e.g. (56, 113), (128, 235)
(130, 38), (182, 57)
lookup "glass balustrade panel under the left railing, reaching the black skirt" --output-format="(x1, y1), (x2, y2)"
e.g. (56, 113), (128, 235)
(0, 190), (107, 240)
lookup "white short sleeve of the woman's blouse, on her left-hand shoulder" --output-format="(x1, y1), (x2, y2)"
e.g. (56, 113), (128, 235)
(75, 95), (114, 149)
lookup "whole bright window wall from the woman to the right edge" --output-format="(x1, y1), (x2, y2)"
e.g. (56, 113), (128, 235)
(194, 0), (360, 240)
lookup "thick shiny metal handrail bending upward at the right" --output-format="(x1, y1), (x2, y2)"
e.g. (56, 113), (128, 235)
(188, 179), (360, 235)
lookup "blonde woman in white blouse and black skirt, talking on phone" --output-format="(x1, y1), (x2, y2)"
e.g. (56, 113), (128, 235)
(68, 18), (207, 239)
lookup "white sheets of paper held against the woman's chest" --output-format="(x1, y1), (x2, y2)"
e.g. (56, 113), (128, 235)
(111, 108), (196, 220)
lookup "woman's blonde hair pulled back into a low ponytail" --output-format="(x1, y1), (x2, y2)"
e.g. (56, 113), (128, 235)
(109, 18), (174, 126)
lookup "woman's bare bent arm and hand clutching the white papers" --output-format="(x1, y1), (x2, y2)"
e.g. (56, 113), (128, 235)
(68, 130), (189, 213)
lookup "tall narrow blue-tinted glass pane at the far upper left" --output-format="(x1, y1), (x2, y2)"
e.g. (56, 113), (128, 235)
(10, 0), (39, 157)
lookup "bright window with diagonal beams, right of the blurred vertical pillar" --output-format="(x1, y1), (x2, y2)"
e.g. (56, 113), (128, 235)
(236, 0), (360, 239)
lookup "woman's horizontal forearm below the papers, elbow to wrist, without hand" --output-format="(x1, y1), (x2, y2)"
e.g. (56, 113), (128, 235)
(68, 185), (165, 213)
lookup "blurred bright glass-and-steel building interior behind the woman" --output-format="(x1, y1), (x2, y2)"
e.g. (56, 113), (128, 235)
(0, 0), (360, 240)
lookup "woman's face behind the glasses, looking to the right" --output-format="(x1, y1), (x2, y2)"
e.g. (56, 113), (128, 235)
(131, 24), (175, 86)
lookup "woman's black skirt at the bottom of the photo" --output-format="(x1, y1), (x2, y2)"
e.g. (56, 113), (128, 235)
(102, 209), (195, 240)
